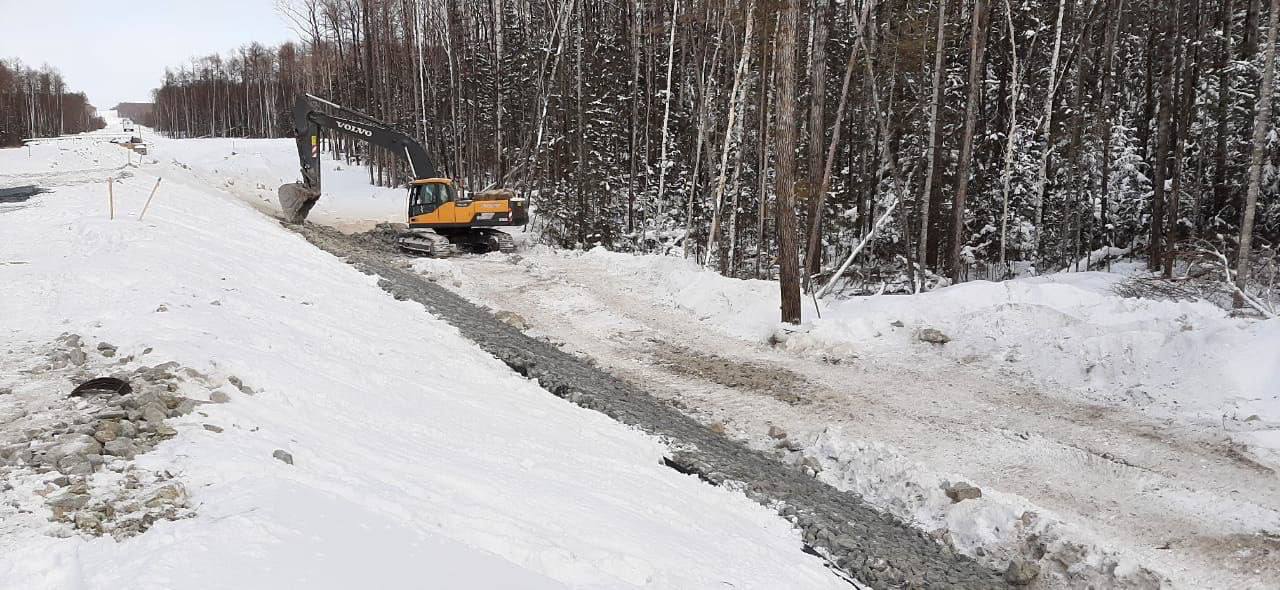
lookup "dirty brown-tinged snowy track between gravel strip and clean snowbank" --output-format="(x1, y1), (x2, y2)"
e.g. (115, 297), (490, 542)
(430, 248), (1280, 587)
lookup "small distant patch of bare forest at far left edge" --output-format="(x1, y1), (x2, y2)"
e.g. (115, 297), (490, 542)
(0, 60), (104, 147)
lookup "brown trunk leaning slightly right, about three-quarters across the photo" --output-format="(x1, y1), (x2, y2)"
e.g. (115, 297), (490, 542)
(947, 0), (991, 283)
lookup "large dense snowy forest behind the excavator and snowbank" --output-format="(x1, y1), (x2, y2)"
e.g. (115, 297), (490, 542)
(149, 0), (1280, 317)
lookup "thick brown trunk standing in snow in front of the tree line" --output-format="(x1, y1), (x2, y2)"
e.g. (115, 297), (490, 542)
(776, 0), (800, 324)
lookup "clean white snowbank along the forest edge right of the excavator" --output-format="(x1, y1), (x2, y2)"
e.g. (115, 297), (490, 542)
(568, 248), (1280, 426)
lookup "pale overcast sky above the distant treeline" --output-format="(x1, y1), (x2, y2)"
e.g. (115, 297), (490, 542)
(0, 0), (294, 110)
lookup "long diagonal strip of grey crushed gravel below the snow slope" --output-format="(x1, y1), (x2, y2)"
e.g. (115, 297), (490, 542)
(289, 224), (1010, 589)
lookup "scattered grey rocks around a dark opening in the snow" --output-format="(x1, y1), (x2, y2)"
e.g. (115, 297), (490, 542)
(0, 334), (240, 539)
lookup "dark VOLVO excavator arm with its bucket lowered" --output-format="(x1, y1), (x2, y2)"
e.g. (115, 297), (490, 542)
(279, 95), (439, 223)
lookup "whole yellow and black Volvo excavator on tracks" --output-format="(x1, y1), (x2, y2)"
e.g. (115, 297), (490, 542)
(278, 93), (529, 257)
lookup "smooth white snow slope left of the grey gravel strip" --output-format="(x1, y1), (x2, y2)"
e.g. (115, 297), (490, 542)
(0, 113), (847, 590)
